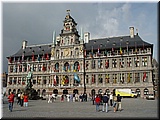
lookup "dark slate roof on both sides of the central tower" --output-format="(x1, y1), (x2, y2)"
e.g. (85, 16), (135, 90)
(9, 35), (153, 57)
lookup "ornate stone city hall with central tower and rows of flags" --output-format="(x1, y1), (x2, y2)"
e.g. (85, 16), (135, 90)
(7, 12), (154, 97)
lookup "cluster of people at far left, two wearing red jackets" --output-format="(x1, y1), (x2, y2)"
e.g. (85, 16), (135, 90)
(7, 92), (28, 112)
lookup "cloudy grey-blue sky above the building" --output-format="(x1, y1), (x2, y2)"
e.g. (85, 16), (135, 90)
(1, 1), (158, 73)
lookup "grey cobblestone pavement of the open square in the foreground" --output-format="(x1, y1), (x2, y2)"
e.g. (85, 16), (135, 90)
(1, 98), (159, 119)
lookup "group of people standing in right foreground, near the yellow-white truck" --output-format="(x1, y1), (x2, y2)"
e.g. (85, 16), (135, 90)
(94, 93), (122, 112)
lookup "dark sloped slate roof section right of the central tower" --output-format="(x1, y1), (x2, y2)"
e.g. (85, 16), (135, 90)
(86, 35), (152, 50)
